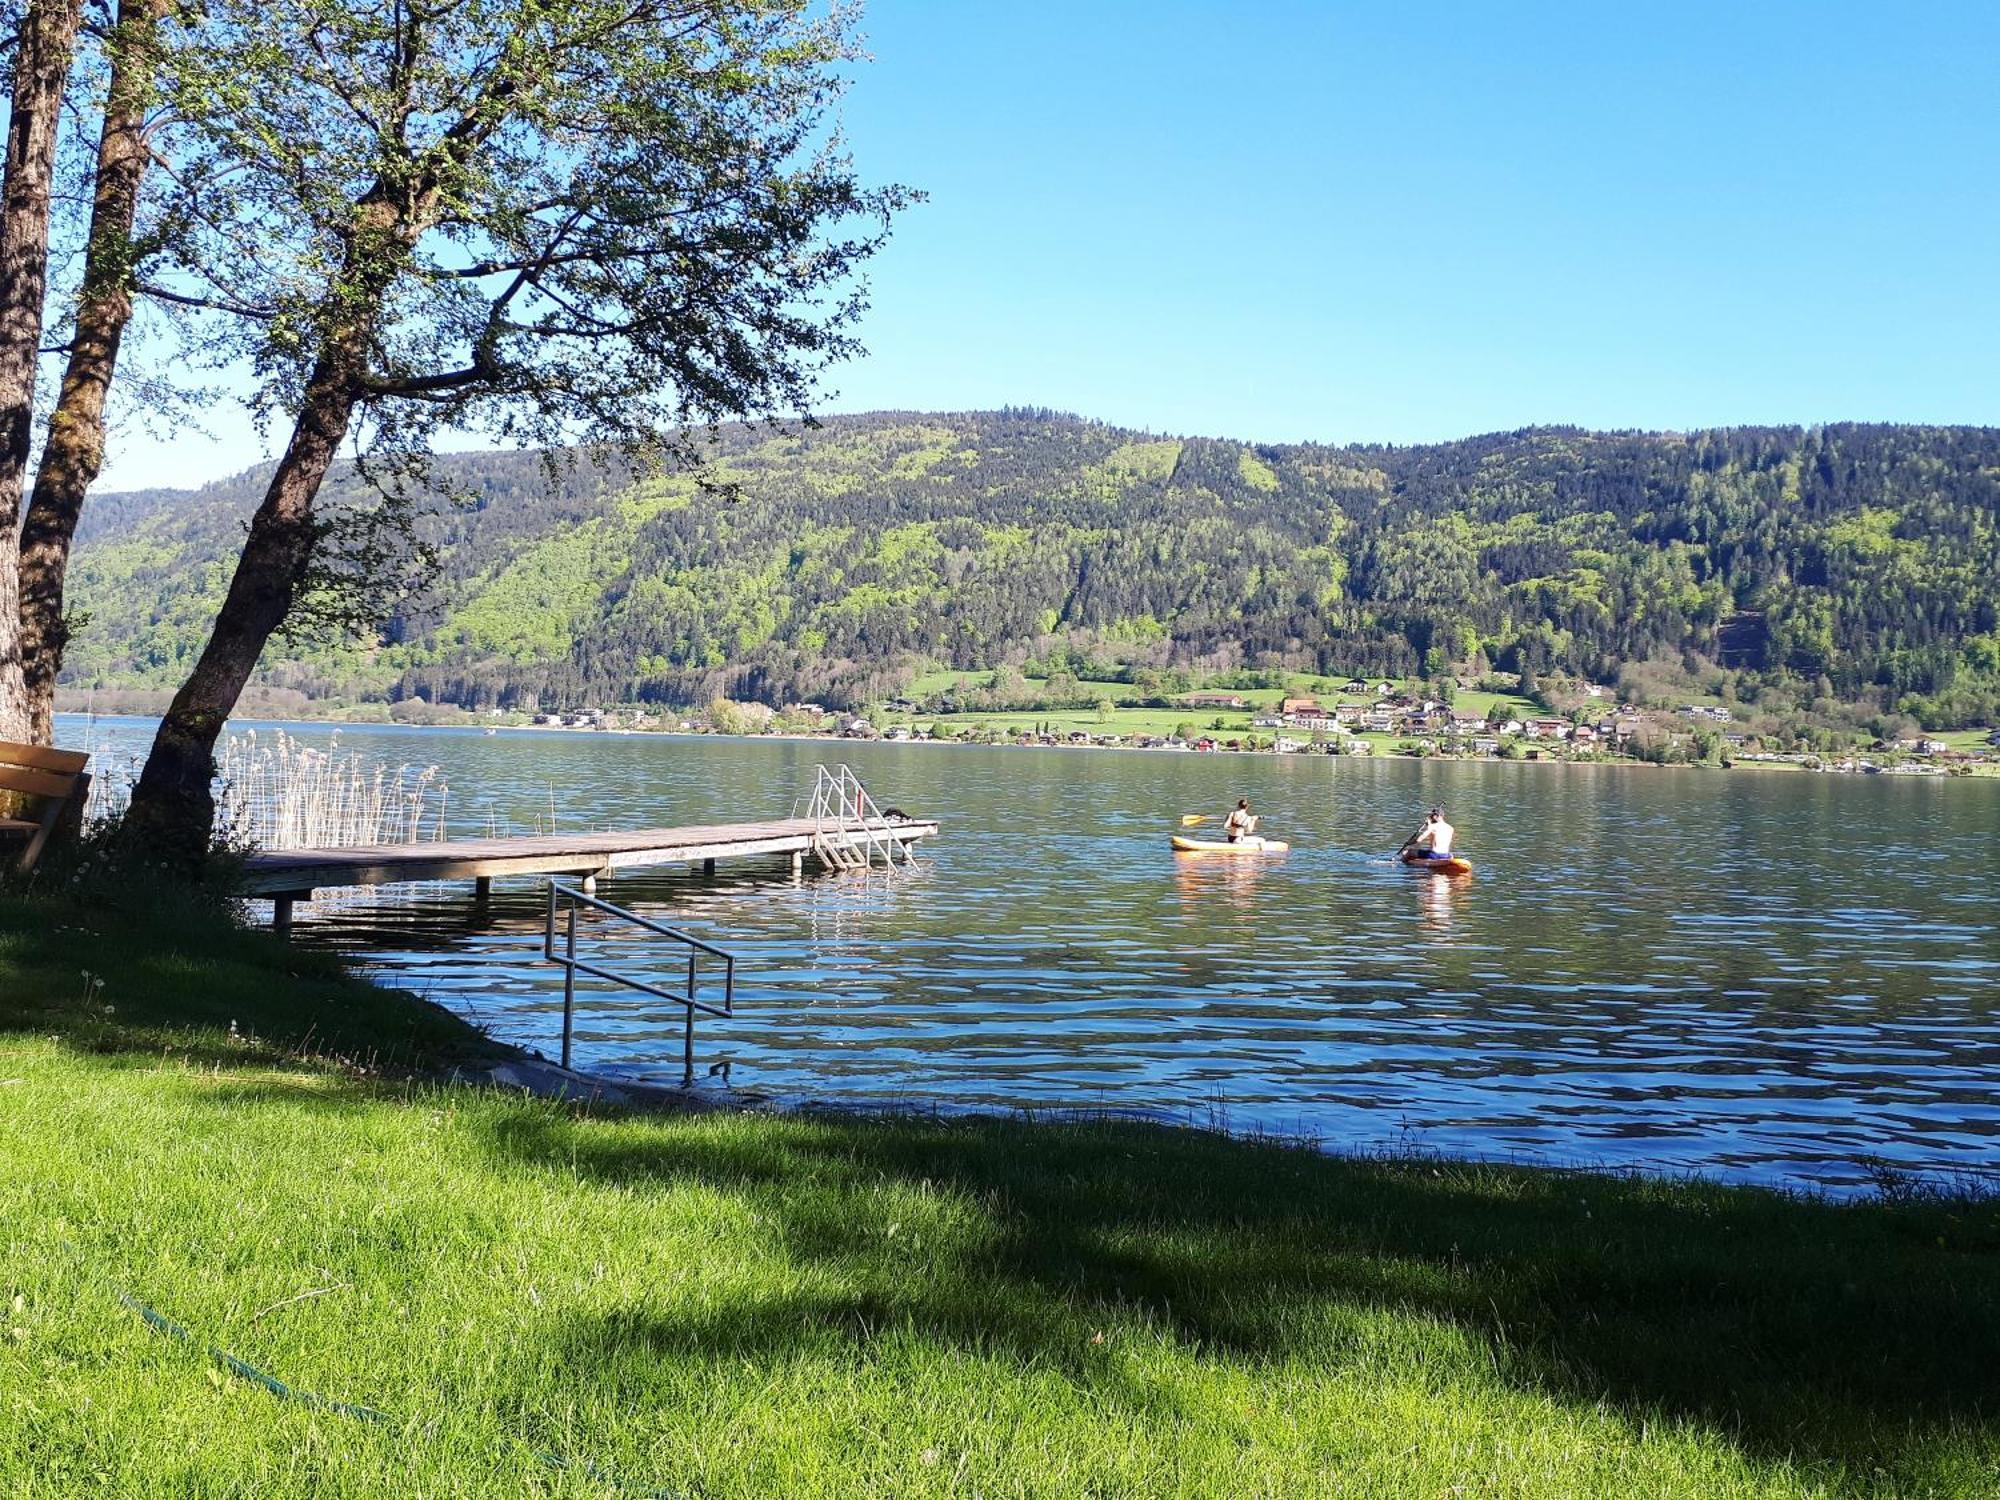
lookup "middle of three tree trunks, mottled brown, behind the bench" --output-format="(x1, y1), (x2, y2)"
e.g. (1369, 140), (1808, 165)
(20, 0), (168, 744)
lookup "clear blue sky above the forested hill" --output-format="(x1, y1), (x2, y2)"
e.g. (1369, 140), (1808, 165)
(97, 0), (2000, 484)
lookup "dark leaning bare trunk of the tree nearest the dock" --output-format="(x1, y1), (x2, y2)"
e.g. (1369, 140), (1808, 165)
(124, 354), (360, 870)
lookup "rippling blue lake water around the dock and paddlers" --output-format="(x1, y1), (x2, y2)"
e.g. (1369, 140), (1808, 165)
(62, 720), (2000, 1188)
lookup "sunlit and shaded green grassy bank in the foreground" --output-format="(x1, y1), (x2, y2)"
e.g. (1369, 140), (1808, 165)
(0, 902), (2000, 1500)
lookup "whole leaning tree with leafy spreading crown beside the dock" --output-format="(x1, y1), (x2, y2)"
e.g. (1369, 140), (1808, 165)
(128, 0), (906, 860)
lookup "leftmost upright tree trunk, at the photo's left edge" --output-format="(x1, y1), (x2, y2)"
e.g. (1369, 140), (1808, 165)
(0, 0), (82, 740)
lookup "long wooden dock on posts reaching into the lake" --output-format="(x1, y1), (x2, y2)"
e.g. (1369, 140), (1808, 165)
(244, 818), (938, 934)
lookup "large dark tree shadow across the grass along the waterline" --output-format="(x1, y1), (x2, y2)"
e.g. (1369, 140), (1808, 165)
(480, 1116), (2000, 1476)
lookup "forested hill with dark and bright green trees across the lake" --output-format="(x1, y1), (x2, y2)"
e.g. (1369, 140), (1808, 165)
(68, 410), (2000, 722)
